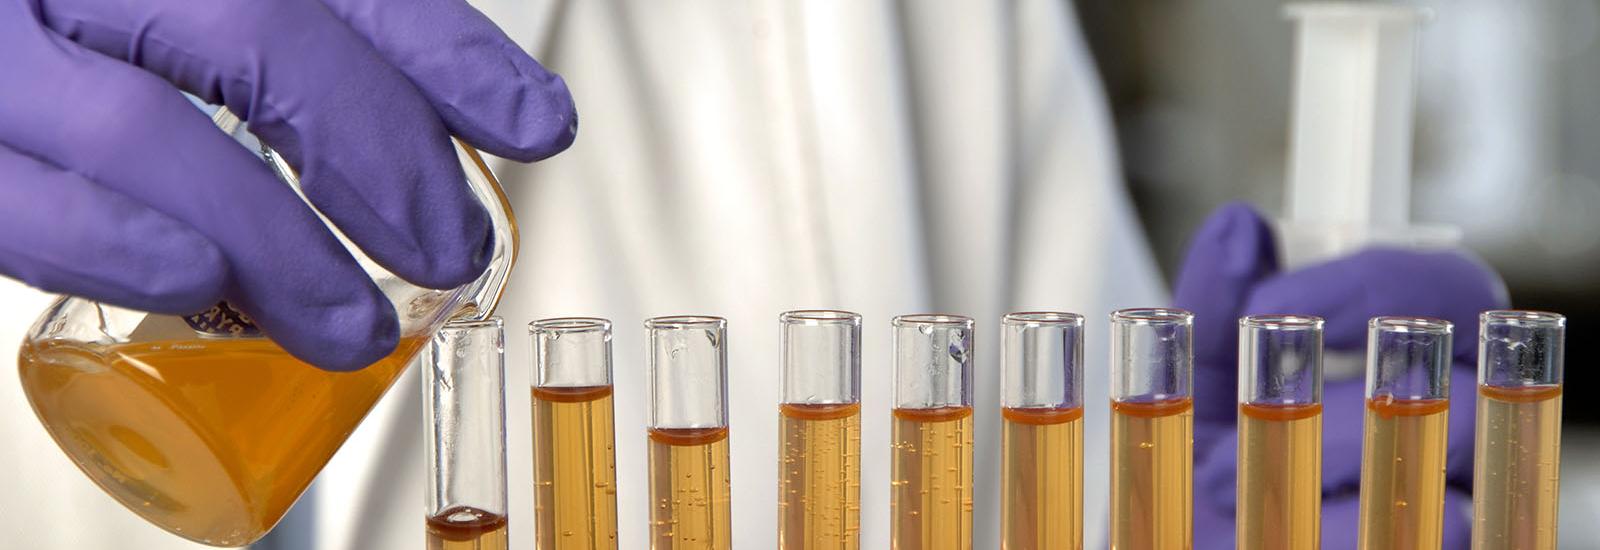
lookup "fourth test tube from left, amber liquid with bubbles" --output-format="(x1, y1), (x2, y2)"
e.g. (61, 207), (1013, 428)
(778, 310), (861, 550)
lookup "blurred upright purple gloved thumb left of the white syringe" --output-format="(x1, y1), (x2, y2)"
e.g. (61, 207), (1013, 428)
(1173, 203), (1290, 422)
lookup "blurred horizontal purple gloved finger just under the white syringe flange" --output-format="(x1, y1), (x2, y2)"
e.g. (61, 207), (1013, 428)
(1245, 248), (1507, 361)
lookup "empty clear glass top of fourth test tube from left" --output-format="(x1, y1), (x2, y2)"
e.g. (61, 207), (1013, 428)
(778, 310), (861, 406)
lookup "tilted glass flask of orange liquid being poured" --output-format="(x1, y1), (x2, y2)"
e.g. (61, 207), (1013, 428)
(18, 107), (517, 547)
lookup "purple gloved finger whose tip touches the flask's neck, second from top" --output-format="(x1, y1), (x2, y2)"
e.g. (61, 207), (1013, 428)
(40, 0), (490, 288)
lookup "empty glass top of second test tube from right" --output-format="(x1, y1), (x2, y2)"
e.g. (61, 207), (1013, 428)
(1366, 317), (1453, 401)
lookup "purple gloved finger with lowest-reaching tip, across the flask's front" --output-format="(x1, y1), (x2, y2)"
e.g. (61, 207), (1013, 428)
(0, 12), (398, 369)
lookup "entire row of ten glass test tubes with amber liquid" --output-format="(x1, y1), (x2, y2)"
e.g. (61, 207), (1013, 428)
(409, 309), (1565, 550)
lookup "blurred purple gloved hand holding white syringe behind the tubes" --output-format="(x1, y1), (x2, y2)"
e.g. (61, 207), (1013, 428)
(1174, 203), (1506, 548)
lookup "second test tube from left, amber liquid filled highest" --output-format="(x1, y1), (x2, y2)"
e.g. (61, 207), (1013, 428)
(528, 317), (618, 550)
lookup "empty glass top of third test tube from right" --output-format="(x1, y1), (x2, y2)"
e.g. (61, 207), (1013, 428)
(1238, 315), (1323, 406)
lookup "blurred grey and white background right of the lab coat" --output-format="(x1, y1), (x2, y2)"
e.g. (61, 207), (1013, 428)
(1075, 0), (1600, 540)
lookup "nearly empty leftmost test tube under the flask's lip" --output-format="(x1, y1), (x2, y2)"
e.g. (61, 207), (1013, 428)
(422, 318), (507, 550)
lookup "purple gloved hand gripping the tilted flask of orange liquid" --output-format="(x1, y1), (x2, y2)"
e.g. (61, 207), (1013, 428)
(0, 0), (578, 369)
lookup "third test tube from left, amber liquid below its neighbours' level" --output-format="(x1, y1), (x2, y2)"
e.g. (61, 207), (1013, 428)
(645, 317), (733, 550)
